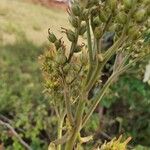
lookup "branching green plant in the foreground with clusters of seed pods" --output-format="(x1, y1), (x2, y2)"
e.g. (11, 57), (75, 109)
(40, 0), (150, 150)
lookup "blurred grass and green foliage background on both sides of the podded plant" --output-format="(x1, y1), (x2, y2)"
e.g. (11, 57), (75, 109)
(0, 0), (150, 150)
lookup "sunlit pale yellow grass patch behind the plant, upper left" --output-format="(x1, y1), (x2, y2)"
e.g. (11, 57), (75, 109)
(0, 0), (68, 45)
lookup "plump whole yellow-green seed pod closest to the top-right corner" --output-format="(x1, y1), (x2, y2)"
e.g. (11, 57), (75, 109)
(134, 8), (146, 23)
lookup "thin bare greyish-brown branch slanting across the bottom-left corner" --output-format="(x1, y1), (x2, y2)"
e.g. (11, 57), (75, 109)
(0, 120), (32, 150)
